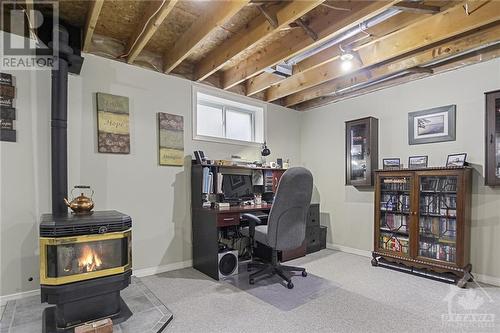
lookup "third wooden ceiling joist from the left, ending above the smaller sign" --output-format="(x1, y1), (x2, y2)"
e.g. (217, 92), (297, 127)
(163, 0), (249, 74)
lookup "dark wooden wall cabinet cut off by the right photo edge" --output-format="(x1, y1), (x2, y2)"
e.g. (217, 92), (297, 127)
(484, 90), (500, 186)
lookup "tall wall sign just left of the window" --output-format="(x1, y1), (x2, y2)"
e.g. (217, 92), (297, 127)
(158, 112), (184, 166)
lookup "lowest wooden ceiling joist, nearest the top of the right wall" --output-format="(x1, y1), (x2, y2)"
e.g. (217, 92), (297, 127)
(294, 42), (500, 111)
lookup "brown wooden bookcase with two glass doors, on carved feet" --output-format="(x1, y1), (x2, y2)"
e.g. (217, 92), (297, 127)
(372, 167), (472, 287)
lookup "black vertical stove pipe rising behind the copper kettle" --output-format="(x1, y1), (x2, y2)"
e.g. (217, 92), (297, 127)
(49, 25), (73, 216)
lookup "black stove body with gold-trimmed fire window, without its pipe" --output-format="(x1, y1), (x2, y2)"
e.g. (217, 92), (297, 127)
(40, 211), (132, 333)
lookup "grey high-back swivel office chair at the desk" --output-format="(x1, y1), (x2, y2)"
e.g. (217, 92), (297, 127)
(242, 167), (313, 289)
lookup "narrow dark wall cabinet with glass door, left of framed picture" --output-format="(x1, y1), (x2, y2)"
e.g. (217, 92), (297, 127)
(345, 117), (378, 186)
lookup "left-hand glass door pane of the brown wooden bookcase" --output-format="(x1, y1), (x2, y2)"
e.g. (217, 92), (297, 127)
(378, 176), (412, 256)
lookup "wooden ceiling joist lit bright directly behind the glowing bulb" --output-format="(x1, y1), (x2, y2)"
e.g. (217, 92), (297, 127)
(283, 23), (500, 107)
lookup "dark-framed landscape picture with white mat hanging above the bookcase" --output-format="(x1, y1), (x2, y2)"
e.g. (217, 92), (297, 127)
(408, 105), (456, 145)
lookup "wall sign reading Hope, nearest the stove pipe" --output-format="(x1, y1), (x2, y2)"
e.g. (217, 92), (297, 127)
(97, 93), (130, 154)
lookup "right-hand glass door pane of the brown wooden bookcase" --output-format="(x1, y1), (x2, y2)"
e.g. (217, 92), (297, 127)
(418, 175), (458, 263)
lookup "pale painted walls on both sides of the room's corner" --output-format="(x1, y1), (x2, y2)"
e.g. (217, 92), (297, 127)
(0, 29), (500, 296)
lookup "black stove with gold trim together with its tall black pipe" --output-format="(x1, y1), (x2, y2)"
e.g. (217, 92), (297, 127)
(40, 25), (132, 333)
